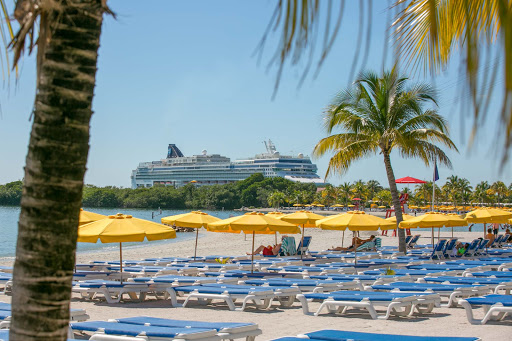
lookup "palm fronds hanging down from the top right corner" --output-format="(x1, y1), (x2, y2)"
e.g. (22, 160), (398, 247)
(261, 0), (512, 161)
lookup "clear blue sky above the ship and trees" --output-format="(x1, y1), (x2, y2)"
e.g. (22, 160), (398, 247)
(0, 0), (506, 187)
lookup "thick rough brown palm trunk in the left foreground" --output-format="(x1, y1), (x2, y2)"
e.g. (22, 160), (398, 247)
(10, 0), (103, 340)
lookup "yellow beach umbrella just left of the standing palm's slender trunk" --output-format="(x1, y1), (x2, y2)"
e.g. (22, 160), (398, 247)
(316, 211), (396, 263)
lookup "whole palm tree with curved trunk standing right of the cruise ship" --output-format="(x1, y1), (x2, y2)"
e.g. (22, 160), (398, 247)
(313, 69), (457, 252)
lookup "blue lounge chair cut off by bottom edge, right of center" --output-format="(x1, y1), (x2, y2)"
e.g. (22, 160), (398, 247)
(272, 329), (480, 341)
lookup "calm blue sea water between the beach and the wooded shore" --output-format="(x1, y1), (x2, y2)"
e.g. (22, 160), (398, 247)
(0, 206), (241, 257)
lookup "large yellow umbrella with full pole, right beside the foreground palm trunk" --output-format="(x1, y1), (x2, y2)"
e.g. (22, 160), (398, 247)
(77, 213), (176, 283)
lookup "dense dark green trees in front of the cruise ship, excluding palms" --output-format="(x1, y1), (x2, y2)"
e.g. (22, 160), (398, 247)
(0, 173), (316, 209)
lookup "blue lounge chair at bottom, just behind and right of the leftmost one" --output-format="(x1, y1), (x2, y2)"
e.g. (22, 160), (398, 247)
(115, 316), (261, 341)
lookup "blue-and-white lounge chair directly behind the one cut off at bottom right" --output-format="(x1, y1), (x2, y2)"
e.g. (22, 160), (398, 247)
(297, 291), (441, 320)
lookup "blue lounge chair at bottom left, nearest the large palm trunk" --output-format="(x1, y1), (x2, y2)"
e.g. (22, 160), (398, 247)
(69, 321), (220, 341)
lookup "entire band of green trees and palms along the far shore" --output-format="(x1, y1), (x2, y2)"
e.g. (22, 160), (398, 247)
(4, 174), (512, 210)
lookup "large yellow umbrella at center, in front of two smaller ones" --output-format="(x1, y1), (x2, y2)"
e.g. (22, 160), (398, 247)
(208, 212), (300, 273)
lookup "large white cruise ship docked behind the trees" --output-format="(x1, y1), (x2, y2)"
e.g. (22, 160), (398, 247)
(131, 140), (325, 188)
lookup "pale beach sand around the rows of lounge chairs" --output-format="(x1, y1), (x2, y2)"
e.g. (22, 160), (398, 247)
(0, 229), (512, 340)
